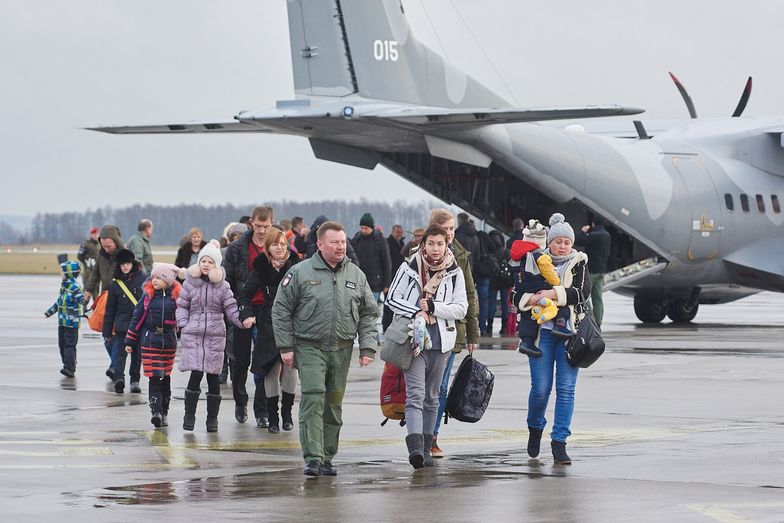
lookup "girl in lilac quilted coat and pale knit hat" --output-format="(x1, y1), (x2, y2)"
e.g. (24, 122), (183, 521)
(177, 240), (248, 432)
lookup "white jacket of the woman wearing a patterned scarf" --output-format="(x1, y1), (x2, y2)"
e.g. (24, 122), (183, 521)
(386, 260), (468, 352)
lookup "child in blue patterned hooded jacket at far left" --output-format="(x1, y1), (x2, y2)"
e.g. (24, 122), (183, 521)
(44, 260), (84, 378)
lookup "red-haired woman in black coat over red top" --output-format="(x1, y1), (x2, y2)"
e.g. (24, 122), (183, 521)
(238, 227), (299, 434)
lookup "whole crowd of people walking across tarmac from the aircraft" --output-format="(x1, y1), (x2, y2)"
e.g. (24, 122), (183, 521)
(52, 206), (609, 476)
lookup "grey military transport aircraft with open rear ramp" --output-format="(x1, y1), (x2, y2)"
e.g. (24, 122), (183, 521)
(94, 0), (784, 322)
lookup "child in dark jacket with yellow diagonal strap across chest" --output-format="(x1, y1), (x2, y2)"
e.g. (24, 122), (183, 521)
(103, 249), (147, 394)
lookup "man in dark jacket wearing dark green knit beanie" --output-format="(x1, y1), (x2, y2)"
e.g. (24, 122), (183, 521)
(351, 212), (392, 302)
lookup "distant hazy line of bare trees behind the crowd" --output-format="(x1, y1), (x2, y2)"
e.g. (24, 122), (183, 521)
(18, 200), (443, 245)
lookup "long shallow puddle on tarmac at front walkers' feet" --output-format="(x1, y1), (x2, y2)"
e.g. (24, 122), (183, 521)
(65, 453), (568, 507)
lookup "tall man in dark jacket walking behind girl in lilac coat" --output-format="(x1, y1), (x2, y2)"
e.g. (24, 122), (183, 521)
(223, 206), (273, 428)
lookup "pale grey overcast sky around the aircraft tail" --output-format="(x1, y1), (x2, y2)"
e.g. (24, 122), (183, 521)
(0, 0), (784, 216)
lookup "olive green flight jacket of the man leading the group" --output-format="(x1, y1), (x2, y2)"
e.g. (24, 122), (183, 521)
(272, 253), (378, 358)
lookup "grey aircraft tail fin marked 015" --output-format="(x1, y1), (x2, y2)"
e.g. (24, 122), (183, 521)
(287, 0), (509, 108)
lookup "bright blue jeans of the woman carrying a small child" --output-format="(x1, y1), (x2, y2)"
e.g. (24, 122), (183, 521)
(528, 329), (578, 442)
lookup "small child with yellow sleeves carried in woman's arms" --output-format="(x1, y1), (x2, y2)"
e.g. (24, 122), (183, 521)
(509, 220), (572, 357)
